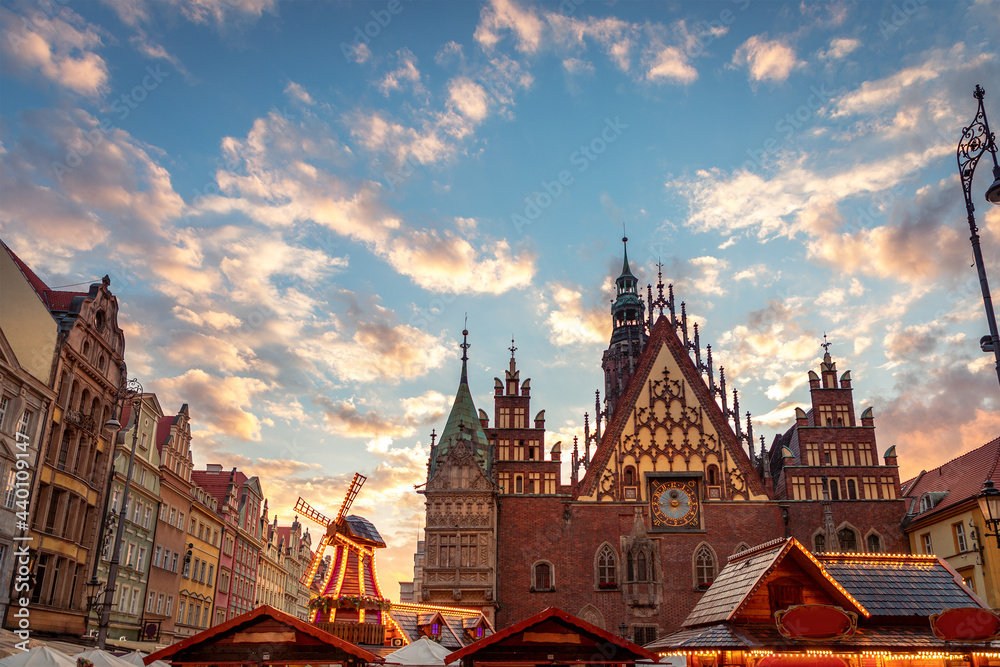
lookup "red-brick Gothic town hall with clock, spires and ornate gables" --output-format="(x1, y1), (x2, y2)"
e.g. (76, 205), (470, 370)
(415, 239), (906, 644)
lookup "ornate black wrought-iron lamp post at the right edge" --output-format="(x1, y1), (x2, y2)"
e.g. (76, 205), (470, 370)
(958, 84), (1000, 388)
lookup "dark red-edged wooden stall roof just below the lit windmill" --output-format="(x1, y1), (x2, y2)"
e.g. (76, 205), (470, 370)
(144, 605), (384, 665)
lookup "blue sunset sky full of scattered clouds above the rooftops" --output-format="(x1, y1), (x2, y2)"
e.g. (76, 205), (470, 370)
(0, 0), (1000, 598)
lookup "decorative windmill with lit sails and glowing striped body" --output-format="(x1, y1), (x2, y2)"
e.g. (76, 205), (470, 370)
(295, 473), (389, 625)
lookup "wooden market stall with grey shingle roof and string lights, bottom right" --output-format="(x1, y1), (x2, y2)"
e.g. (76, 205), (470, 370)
(646, 538), (1000, 667)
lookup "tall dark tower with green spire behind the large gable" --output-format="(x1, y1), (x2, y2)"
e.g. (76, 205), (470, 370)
(601, 236), (646, 419)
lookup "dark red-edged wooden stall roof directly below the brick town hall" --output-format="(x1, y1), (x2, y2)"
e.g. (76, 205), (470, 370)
(445, 607), (657, 665)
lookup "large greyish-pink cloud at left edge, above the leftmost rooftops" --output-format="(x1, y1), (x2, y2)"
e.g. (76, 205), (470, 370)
(0, 109), (183, 267)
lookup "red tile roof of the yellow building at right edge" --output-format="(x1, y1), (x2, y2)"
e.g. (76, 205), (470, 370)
(903, 437), (1000, 519)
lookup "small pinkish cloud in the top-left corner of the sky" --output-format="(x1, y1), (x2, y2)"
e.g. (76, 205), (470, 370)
(0, 7), (108, 97)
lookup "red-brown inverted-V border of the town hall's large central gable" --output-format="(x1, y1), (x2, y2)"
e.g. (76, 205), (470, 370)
(578, 314), (766, 496)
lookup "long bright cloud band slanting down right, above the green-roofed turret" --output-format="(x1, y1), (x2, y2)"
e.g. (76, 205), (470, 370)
(201, 107), (535, 294)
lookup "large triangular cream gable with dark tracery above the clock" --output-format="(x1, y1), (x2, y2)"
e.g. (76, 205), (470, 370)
(579, 316), (767, 501)
